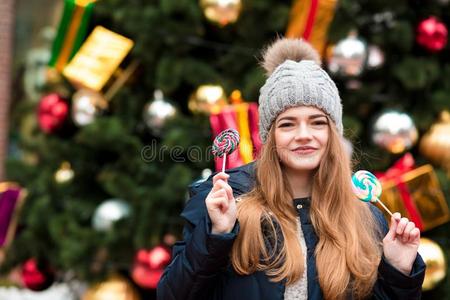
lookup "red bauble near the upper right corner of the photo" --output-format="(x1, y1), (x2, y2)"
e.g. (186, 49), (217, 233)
(416, 17), (448, 52)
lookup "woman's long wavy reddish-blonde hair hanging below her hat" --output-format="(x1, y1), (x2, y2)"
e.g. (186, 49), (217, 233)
(231, 122), (381, 299)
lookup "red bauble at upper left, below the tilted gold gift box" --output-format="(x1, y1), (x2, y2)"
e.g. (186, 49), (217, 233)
(38, 93), (69, 133)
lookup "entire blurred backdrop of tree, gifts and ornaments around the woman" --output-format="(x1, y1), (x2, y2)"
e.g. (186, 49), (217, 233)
(0, 0), (450, 300)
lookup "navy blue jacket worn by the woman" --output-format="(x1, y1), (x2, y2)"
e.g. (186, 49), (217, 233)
(157, 163), (425, 300)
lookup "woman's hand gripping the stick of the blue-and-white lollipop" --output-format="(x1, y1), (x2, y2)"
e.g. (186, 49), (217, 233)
(383, 212), (420, 275)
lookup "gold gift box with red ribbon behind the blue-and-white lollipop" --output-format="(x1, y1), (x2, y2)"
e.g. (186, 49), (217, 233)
(380, 165), (450, 231)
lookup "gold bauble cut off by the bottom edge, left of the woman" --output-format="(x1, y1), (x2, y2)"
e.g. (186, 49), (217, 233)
(82, 275), (141, 300)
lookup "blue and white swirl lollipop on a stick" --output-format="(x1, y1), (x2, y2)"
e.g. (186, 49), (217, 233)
(352, 170), (392, 216)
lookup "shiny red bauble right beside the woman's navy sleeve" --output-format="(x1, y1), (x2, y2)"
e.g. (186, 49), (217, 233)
(131, 246), (171, 289)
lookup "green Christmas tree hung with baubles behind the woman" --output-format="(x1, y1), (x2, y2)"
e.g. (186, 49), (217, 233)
(1, 0), (450, 299)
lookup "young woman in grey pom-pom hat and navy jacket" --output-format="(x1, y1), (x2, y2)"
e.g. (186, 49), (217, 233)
(157, 39), (425, 300)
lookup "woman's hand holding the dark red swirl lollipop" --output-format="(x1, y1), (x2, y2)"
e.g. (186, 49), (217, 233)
(205, 172), (237, 234)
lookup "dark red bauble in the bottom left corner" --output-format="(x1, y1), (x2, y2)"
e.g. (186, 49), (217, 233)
(21, 258), (54, 291)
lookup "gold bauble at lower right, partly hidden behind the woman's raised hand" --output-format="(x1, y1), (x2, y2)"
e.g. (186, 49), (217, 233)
(418, 238), (447, 291)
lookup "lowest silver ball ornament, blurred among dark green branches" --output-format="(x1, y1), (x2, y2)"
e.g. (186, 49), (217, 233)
(92, 199), (131, 231)
